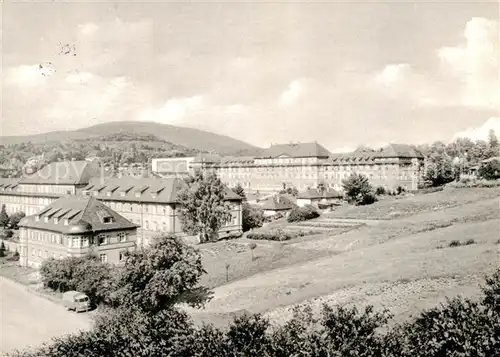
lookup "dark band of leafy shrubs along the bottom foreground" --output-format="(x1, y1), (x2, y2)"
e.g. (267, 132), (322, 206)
(13, 270), (500, 357)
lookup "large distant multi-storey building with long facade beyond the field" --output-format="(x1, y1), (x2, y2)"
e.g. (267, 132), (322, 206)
(191, 143), (424, 192)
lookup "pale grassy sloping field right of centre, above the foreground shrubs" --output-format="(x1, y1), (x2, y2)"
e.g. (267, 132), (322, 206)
(188, 189), (500, 323)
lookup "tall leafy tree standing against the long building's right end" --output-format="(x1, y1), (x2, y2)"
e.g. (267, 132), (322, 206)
(178, 171), (231, 242)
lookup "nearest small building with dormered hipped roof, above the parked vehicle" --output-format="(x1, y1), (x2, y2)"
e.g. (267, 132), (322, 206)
(19, 196), (138, 268)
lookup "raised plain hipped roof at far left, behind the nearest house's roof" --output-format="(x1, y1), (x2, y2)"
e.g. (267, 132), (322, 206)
(20, 161), (100, 185)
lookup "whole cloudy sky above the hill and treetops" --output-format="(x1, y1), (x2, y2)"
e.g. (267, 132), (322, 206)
(0, 1), (500, 151)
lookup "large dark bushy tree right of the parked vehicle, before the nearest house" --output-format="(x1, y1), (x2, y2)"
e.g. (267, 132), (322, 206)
(111, 236), (210, 313)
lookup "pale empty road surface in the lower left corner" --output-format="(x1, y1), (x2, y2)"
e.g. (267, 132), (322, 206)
(0, 277), (91, 355)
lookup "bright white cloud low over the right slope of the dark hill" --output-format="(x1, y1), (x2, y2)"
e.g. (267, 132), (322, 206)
(140, 96), (204, 124)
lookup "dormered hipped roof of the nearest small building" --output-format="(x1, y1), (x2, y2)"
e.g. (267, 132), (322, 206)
(19, 196), (138, 234)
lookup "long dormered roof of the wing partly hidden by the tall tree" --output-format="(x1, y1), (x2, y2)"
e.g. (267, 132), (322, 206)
(83, 177), (241, 203)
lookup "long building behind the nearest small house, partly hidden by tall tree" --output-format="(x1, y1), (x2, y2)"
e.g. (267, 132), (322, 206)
(0, 161), (242, 245)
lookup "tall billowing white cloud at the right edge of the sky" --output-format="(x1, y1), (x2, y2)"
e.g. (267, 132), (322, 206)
(438, 18), (500, 109)
